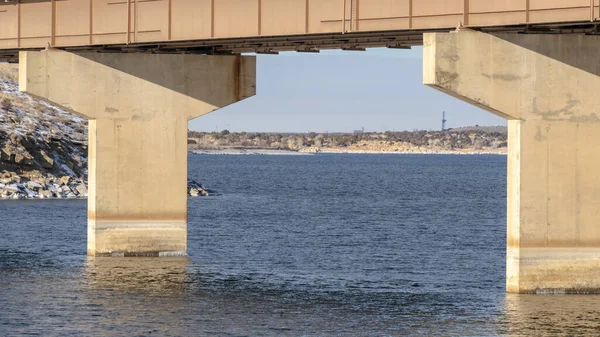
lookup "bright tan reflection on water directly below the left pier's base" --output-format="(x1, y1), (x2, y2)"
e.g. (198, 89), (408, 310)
(82, 257), (189, 296)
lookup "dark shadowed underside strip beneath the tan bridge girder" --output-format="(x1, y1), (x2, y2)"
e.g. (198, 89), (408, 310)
(0, 22), (600, 63)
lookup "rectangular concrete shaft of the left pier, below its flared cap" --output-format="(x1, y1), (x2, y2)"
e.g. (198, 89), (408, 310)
(88, 118), (188, 255)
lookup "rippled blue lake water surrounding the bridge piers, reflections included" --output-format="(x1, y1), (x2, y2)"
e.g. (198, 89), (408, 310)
(0, 154), (600, 336)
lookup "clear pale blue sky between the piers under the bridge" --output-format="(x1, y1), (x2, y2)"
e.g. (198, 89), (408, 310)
(189, 47), (506, 132)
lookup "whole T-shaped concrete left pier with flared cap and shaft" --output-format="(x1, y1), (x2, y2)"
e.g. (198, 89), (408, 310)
(19, 50), (256, 256)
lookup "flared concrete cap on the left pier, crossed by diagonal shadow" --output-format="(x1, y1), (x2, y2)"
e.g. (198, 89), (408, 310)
(19, 50), (256, 120)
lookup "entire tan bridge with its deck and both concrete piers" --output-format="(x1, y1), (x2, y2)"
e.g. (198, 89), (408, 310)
(0, 0), (600, 293)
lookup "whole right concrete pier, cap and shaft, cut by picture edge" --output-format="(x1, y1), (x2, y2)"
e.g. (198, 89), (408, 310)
(423, 31), (600, 293)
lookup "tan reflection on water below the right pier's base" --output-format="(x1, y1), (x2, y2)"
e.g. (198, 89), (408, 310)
(502, 294), (600, 336)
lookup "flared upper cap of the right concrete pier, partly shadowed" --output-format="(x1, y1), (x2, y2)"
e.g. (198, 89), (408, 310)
(423, 31), (600, 122)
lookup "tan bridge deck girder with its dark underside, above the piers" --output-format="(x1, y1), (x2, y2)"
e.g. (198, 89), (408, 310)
(0, 0), (600, 61)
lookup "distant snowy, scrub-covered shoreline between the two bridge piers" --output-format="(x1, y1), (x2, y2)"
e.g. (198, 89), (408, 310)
(188, 127), (508, 155)
